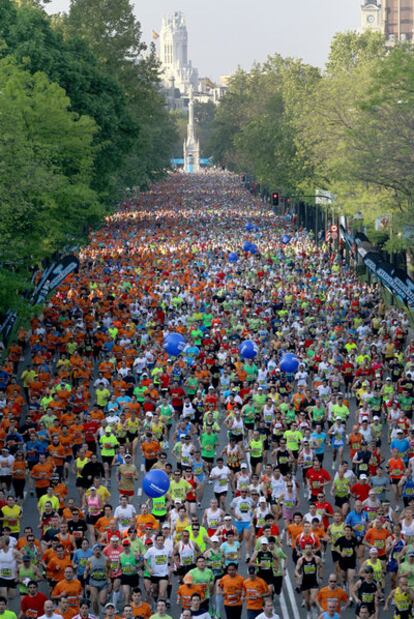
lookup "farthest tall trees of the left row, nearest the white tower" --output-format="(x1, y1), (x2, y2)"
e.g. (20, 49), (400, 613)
(64, 0), (177, 187)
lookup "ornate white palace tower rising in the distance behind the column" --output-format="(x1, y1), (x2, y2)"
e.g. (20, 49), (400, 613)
(160, 11), (198, 94)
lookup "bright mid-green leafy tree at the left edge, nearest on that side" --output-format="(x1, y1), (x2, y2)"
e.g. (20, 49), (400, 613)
(0, 58), (98, 309)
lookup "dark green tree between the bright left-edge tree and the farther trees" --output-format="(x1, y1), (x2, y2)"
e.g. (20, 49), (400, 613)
(0, 0), (137, 201)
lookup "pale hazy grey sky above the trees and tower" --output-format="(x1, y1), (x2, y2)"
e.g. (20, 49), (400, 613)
(47, 0), (361, 79)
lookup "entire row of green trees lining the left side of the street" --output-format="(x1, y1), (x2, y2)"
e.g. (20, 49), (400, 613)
(0, 0), (176, 312)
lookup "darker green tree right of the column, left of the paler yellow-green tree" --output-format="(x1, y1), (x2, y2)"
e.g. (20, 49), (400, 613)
(211, 55), (319, 194)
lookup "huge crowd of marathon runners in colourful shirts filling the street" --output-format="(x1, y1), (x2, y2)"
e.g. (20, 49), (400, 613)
(0, 173), (414, 619)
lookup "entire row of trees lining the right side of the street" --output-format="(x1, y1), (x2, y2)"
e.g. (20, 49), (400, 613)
(211, 33), (414, 266)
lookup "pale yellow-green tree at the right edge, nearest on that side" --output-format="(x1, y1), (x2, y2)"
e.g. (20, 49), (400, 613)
(298, 33), (414, 230)
